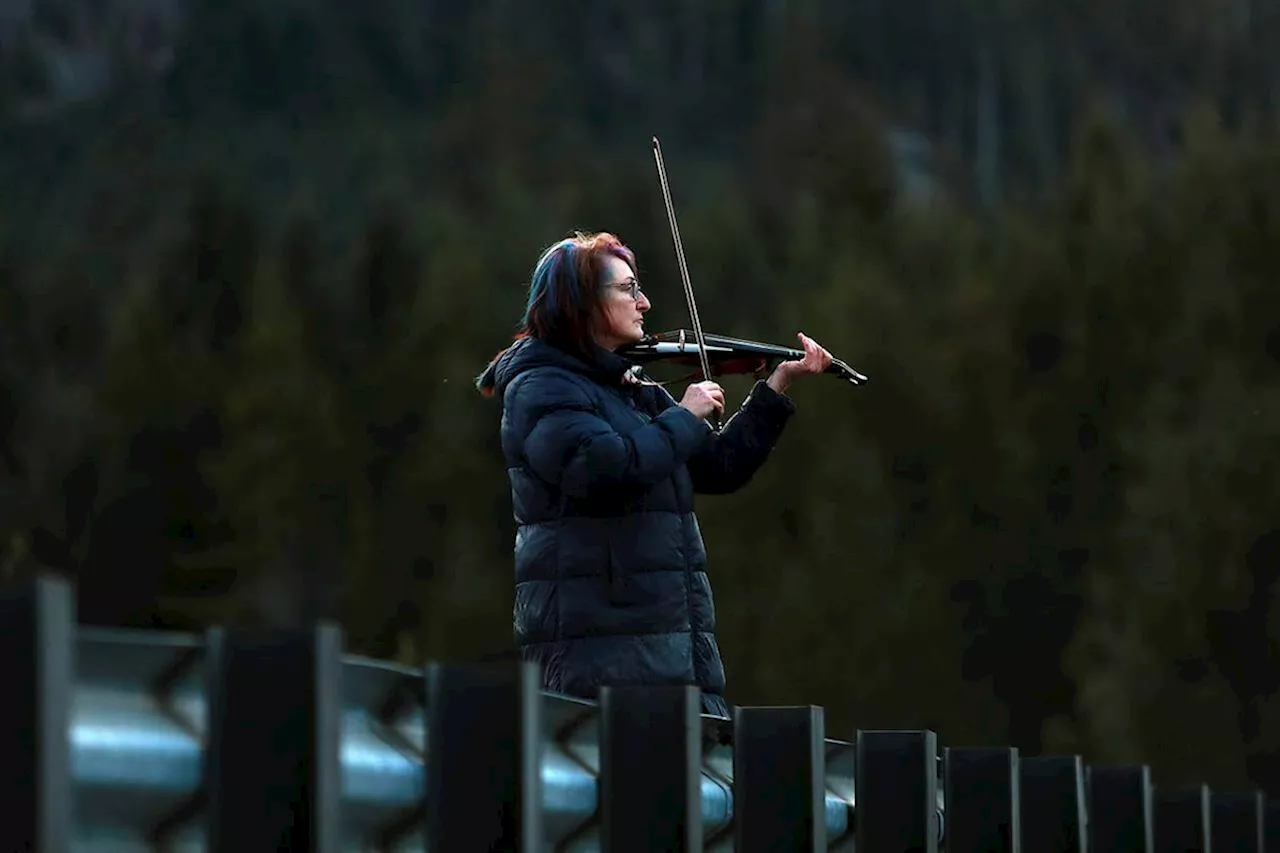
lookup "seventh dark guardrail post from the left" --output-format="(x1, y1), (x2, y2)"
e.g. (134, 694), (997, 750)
(943, 748), (1021, 853)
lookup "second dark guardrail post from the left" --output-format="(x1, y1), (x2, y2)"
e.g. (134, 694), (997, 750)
(205, 625), (343, 853)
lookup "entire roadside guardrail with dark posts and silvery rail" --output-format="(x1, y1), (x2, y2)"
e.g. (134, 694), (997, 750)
(0, 578), (1280, 853)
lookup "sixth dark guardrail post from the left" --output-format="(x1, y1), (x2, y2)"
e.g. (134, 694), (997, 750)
(854, 730), (938, 853)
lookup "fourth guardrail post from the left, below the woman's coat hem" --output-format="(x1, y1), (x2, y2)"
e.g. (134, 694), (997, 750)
(599, 685), (703, 853)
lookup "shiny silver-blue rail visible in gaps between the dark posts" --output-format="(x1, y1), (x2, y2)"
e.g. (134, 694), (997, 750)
(69, 629), (870, 850)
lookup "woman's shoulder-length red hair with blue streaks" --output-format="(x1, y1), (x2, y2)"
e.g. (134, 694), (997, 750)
(480, 231), (637, 393)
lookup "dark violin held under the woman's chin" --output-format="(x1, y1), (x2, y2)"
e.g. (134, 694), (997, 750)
(618, 329), (867, 386)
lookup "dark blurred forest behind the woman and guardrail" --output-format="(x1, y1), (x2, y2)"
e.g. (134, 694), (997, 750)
(0, 0), (1280, 795)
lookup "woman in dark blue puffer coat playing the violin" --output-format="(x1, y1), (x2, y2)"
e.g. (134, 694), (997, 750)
(476, 233), (831, 716)
